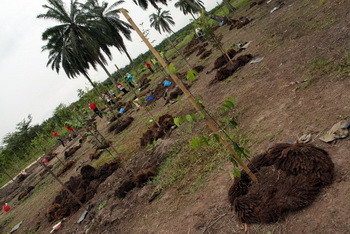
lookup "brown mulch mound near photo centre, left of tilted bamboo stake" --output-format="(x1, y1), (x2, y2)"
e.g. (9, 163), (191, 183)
(140, 114), (175, 146)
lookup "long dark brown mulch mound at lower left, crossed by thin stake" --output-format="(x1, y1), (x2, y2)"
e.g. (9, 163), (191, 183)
(45, 161), (119, 222)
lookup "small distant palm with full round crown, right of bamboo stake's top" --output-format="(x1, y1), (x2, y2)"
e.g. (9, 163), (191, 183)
(149, 8), (175, 34)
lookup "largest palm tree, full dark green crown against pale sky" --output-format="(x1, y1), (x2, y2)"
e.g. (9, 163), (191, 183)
(37, 0), (114, 88)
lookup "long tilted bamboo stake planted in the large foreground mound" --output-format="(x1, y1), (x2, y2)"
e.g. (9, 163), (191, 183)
(120, 8), (258, 182)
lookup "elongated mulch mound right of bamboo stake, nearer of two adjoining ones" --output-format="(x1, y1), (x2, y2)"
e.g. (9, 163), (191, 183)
(209, 54), (253, 85)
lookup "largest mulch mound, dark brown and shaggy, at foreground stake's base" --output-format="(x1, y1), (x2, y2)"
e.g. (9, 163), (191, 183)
(228, 143), (334, 223)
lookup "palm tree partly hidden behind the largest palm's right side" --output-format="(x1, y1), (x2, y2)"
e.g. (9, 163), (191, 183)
(83, 0), (132, 62)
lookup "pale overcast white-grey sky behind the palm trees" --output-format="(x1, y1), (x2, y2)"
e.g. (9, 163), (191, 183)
(0, 0), (221, 144)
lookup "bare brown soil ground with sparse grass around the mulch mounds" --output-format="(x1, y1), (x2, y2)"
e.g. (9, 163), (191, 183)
(0, 0), (350, 233)
